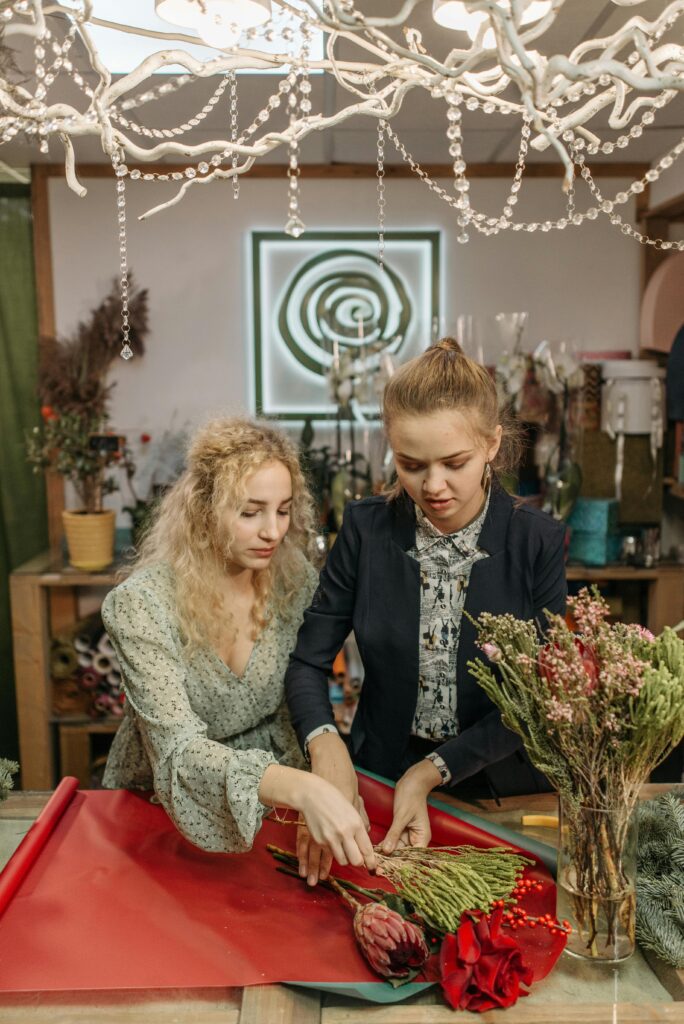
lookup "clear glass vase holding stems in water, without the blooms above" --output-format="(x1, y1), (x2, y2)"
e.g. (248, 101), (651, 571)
(556, 798), (637, 963)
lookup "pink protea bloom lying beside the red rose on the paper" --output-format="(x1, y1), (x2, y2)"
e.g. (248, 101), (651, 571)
(354, 903), (430, 978)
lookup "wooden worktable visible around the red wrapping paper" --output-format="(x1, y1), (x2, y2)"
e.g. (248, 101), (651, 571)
(0, 785), (684, 1024)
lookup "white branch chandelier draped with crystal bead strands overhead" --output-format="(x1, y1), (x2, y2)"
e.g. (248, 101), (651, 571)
(0, 0), (684, 354)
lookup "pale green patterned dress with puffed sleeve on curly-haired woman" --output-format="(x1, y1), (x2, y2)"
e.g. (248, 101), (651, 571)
(102, 563), (317, 853)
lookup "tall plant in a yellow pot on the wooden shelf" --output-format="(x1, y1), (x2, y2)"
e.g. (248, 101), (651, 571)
(27, 281), (148, 571)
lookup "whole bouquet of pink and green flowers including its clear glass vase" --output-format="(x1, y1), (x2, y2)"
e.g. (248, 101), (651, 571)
(469, 589), (684, 959)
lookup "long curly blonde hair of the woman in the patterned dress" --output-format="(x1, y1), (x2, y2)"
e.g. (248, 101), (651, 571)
(135, 417), (314, 649)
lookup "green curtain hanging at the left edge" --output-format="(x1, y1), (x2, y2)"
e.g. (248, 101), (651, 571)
(0, 184), (47, 759)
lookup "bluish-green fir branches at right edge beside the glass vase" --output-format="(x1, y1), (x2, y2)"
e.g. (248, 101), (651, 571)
(636, 788), (684, 969)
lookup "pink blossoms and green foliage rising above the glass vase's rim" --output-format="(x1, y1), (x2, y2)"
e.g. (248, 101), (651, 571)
(469, 591), (684, 811)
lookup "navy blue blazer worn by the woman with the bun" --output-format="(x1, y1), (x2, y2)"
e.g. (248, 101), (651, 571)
(285, 479), (566, 783)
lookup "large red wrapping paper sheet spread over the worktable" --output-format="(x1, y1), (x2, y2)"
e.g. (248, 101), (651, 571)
(0, 776), (564, 992)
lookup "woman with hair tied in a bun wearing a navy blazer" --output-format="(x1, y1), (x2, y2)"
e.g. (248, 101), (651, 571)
(286, 338), (566, 877)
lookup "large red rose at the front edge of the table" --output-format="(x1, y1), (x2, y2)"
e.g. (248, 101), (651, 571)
(439, 907), (532, 1013)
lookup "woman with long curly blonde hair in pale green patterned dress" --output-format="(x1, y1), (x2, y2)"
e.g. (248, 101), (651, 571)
(102, 419), (375, 868)
